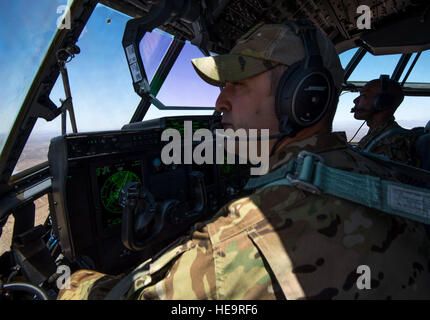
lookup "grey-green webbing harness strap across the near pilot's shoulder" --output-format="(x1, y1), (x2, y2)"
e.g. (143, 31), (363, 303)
(245, 151), (430, 224)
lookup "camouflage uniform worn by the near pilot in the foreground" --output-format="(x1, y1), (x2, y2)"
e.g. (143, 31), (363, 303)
(59, 133), (430, 299)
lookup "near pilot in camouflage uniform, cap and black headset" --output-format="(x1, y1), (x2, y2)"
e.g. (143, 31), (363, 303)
(59, 23), (430, 300)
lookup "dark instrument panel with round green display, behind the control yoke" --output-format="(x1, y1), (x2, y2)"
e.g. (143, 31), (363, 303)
(48, 116), (249, 274)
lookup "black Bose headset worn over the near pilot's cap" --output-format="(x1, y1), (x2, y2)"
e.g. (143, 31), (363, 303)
(275, 20), (336, 137)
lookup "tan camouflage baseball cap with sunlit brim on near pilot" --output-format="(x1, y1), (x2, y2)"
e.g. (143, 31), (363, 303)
(191, 24), (344, 88)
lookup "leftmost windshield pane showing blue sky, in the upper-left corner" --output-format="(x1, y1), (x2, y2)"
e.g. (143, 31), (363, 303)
(0, 0), (74, 158)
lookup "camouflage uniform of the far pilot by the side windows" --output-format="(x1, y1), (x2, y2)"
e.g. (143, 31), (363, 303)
(357, 117), (421, 167)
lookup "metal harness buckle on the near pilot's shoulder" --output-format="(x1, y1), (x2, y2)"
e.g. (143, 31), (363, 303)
(287, 150), (324, 194)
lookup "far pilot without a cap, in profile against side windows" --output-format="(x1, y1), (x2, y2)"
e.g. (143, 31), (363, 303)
(351, 76), (421, 167)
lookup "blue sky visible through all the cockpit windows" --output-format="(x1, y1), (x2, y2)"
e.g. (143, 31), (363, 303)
(0, 0), (430, 151)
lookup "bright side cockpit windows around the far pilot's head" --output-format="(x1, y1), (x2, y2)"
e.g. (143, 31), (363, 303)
(333, 48), (430, 144)
